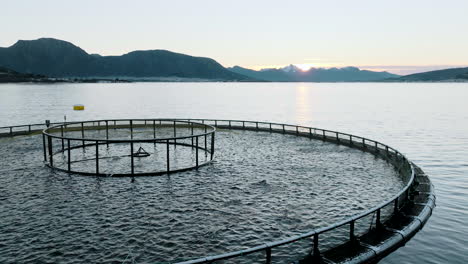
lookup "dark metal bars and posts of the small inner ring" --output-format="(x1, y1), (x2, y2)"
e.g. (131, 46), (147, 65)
(42, 119), (216, 177)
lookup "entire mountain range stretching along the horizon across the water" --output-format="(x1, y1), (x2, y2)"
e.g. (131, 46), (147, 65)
(0, 38), (468, 82)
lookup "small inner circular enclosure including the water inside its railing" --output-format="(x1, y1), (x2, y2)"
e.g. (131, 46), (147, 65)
(42, 119), (216, 177)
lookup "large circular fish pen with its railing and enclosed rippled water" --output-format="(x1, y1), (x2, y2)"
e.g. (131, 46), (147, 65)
(0, 119), (435, 263)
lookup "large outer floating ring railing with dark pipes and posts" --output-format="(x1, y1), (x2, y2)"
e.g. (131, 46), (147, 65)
(0, 119), (435, 264)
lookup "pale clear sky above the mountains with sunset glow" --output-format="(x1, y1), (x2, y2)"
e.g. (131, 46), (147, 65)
(0, 0), (468, 73)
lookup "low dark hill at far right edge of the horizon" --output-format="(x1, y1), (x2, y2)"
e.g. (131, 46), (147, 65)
(388, 67), (468, 82)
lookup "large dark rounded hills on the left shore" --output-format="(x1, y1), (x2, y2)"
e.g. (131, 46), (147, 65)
(0, 38), (251, 81)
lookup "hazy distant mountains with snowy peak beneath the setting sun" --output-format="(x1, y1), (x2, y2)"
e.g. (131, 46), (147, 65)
(228, 65), (399, 82)
